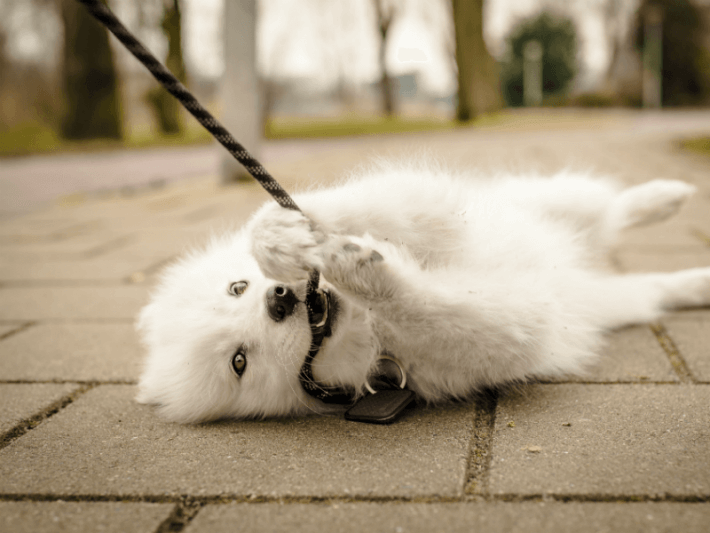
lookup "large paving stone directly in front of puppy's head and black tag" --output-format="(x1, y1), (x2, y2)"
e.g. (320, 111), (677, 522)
(0, 385), (473, 497)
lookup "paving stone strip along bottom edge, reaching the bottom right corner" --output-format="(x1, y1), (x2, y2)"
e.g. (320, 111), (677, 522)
(185, 502), (710, 533)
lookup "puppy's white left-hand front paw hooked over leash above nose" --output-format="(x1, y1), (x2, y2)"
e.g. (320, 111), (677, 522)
(251, 206), (325, 281)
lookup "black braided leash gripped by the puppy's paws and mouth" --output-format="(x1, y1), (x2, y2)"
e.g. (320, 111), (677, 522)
(77, 0), (354, 403)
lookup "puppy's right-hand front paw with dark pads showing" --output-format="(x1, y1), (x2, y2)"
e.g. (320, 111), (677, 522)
(322, 236), (395, 300)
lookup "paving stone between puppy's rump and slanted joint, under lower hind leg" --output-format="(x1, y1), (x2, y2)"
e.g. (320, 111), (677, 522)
(568, 326), (679, 383)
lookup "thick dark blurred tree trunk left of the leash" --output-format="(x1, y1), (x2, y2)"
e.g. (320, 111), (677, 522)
(60, 0), (122, 139)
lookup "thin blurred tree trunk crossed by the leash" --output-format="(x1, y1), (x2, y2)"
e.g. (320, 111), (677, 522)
(148, 0), (187, 134)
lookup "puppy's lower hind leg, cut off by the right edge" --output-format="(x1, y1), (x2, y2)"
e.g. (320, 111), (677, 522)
(576, 267), (710, 329)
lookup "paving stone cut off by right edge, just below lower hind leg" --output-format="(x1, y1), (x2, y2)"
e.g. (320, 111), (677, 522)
(663, 310), (710, 383)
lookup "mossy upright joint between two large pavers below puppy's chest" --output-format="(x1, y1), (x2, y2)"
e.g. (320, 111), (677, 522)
(464, 390), (498, 495)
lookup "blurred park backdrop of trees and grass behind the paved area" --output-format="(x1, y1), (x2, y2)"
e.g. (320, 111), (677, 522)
(0, 0), (710, 182)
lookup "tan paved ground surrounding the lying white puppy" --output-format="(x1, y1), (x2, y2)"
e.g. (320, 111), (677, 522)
(0, 111), (710, 533)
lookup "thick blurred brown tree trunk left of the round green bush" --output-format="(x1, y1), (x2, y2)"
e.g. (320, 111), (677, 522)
(452, 0), (502, 122)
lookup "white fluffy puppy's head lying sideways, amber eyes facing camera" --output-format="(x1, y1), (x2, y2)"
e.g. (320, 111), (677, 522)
(137, 233), (377, 423)
